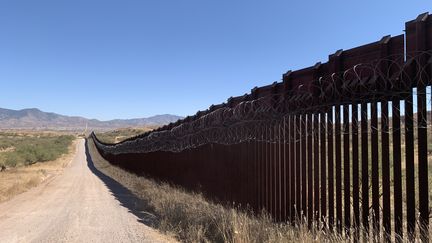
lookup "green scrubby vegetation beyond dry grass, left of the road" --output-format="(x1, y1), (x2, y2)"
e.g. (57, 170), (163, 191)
(0, 132), (74, 167)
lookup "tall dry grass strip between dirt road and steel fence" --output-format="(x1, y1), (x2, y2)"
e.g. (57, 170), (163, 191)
(88, 140), (349, 243)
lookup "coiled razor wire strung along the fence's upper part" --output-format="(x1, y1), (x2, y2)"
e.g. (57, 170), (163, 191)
(96, 51), (432, 154)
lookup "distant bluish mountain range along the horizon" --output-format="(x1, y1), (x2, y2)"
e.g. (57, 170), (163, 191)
(0, 108), (182, 130)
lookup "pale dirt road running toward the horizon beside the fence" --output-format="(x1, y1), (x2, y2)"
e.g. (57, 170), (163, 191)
(0, 140), (173, 242)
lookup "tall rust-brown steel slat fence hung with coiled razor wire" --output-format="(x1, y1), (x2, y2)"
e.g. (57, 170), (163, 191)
(92, 14), (432, 241)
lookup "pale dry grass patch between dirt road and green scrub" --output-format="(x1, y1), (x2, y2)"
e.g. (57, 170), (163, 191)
(0, 141), (77, 202)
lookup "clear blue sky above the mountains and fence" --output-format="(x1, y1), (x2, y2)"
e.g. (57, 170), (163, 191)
(0, 0), (432, 120)
